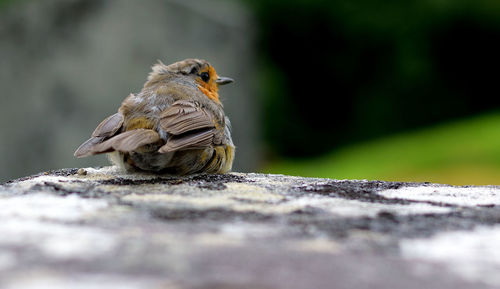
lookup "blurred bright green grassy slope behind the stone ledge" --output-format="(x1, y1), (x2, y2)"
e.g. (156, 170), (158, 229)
(265, 113), (500, 185)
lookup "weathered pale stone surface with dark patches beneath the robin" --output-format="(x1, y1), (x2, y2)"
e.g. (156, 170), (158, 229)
(0, 167), (500, 289)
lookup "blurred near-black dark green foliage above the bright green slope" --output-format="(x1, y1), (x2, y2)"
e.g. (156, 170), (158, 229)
(248, 0), (500, 157)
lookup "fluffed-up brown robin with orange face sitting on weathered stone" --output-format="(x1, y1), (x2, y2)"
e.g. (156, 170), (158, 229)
(75, 59), (234, 175)
